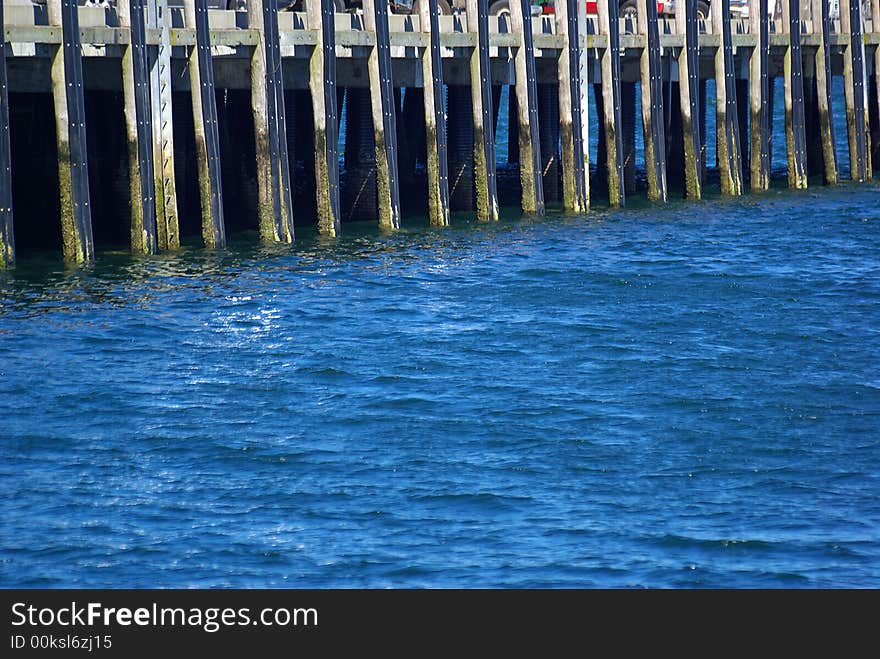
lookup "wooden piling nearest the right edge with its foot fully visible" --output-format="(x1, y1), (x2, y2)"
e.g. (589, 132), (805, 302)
(840, 0), (871, 181)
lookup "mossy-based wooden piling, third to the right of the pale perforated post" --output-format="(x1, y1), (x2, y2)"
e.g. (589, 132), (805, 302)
(306, 0), (341, 236)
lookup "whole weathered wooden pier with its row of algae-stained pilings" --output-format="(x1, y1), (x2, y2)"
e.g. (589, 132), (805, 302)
(0, 0), (880, 266)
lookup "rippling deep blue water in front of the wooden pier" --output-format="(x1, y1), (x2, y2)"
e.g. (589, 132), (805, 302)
(0, 178), (880, 587)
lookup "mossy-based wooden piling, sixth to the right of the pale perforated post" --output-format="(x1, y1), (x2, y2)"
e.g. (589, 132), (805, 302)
(467, 0), (498, 221)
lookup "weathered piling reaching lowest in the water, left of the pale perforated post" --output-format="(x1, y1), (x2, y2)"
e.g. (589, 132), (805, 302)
(47, 0), (95, 263)
